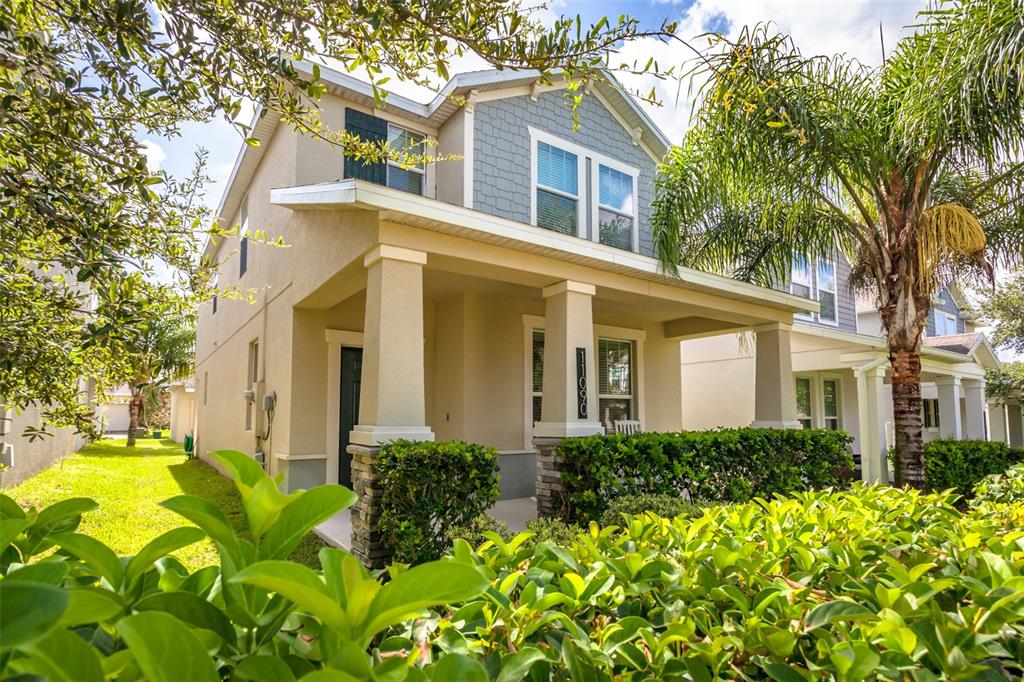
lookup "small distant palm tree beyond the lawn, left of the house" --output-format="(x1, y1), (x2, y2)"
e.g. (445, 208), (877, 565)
(127, 313), (196, 447)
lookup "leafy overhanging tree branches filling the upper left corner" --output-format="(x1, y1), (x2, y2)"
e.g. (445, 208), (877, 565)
(0, 0), (672, 431)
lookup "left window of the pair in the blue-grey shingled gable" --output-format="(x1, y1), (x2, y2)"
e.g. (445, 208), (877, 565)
(536, 141), (580, 235)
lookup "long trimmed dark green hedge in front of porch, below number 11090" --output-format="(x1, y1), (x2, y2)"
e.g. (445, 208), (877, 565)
(557, 428), (853, 522)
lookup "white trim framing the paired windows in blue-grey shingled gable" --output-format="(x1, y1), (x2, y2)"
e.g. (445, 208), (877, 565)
(527, 126), (640, 253)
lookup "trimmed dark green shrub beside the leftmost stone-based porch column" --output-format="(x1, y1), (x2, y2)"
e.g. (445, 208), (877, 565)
(374, 440), (500, 563)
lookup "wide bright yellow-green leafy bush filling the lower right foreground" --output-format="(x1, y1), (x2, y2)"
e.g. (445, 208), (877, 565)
(452, 484), (1024, 680)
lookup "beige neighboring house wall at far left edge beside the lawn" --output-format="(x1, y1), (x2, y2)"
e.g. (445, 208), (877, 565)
(0, 381), (92, 487)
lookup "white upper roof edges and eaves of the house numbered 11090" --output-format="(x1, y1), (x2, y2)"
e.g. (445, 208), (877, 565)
(204, 60), (671, 260)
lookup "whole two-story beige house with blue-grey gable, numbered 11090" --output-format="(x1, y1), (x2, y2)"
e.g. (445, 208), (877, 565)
(196, 62), (818, 555)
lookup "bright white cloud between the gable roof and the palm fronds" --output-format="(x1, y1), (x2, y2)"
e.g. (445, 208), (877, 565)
(612, 0), (927, 142)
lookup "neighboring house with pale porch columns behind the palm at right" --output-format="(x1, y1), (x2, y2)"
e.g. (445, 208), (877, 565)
(683, 254), (998, 480)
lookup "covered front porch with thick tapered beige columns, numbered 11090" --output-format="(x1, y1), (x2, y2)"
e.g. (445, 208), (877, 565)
(272, 184), (814, 552)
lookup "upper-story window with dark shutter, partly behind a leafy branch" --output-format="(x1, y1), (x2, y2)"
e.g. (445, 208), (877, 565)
(345, 108), (425, 195)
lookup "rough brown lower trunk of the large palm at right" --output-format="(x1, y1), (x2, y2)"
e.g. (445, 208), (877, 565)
(889, 346), (925, 487)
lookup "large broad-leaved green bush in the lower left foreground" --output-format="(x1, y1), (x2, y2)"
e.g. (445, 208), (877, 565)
(0, 452), (487, 682)
